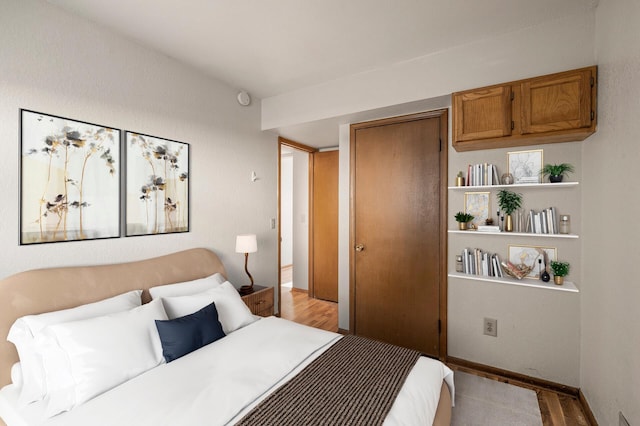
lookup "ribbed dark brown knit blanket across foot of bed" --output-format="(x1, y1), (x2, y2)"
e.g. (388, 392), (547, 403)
(236, 335), (420, 426)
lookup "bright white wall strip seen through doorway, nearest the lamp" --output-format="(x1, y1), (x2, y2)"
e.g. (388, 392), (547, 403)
(280, 154), (293, 267)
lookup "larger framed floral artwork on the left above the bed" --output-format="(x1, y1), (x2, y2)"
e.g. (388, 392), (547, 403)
(20, 109), (120, 245)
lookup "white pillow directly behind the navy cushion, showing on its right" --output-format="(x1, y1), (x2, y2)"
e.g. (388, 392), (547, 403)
(162, 281), (256, 334)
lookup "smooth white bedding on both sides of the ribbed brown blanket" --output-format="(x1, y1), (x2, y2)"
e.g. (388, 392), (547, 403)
(0, 317), (454, 426)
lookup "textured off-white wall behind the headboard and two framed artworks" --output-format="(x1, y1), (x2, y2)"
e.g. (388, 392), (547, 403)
(0, 0), (277, 285)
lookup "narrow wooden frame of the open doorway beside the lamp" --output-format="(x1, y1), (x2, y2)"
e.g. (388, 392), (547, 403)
(277, 136), (318, 316)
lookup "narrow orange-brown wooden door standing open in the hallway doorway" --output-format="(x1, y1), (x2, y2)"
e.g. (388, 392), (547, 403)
(311, 151), (338, 302)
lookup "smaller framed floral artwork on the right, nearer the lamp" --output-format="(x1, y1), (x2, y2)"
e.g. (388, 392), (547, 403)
(125, 131), (189, 237)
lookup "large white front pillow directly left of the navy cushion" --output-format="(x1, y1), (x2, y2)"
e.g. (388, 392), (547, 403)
(38, 300), (167, 417)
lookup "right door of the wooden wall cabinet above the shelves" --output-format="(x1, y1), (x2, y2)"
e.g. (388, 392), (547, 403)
(520, 69), (592, 134)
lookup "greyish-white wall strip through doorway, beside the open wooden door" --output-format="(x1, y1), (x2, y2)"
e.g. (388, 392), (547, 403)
(293, 150), (309, 290)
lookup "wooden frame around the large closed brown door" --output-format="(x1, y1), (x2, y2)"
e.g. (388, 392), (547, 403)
(349, 109), (449, 360)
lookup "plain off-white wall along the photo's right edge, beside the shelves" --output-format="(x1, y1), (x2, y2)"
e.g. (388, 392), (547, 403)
(580, 0), (640, 425)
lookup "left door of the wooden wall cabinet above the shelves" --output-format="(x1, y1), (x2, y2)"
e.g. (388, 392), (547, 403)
(453, 85), (511, 142)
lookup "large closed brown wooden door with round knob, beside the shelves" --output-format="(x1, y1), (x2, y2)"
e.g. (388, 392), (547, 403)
(351, 111), (447, 356)
